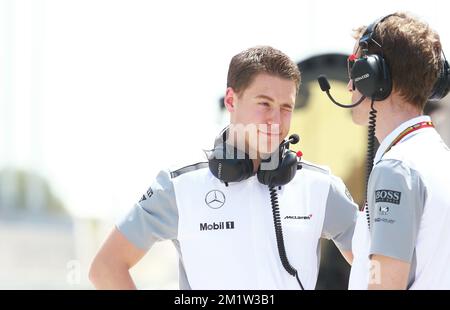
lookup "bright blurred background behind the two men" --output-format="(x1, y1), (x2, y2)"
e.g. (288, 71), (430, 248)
(0, 0), (450, 289)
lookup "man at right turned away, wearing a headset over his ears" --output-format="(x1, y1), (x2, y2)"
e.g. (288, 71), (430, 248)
(348, 12), (450, 289)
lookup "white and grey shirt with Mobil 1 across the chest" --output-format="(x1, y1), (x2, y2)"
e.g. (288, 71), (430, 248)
(117, 162), (357, 289)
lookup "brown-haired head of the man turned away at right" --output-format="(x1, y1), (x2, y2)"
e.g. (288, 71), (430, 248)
(348, 12), (442, 125)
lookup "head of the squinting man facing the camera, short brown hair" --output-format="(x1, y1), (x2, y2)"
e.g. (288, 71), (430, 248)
(224, 46), (300, 154)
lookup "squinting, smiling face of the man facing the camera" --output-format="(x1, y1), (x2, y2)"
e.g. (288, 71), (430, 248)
(225, 73), (296, 156)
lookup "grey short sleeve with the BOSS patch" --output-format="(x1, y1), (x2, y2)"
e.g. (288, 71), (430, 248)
(368, 159), (427, 263)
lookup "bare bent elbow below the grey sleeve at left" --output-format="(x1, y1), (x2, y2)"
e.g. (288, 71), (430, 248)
(89, 228), (146, 290)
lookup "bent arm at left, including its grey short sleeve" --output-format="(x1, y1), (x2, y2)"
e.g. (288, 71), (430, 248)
(89, 171), (178, 289)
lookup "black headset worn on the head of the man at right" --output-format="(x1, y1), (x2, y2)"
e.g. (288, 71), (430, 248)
(349, 14), (450, 101)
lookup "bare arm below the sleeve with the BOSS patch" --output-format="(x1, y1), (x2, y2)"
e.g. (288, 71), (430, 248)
(369, 255), (411, 290)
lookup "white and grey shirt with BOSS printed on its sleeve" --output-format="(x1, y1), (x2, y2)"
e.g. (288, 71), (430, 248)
(349, 116), (450, 289)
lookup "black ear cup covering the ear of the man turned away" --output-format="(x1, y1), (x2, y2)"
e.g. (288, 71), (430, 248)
(351, 54), (392, 101)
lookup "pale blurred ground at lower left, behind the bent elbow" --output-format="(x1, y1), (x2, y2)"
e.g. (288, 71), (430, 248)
(0, 209), (178, 289)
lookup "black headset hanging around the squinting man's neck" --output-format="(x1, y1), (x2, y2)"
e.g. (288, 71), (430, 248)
(208, 127), (298, 186)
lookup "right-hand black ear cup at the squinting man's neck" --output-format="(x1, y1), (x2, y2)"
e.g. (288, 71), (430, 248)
(258, 150), (298, 186)
